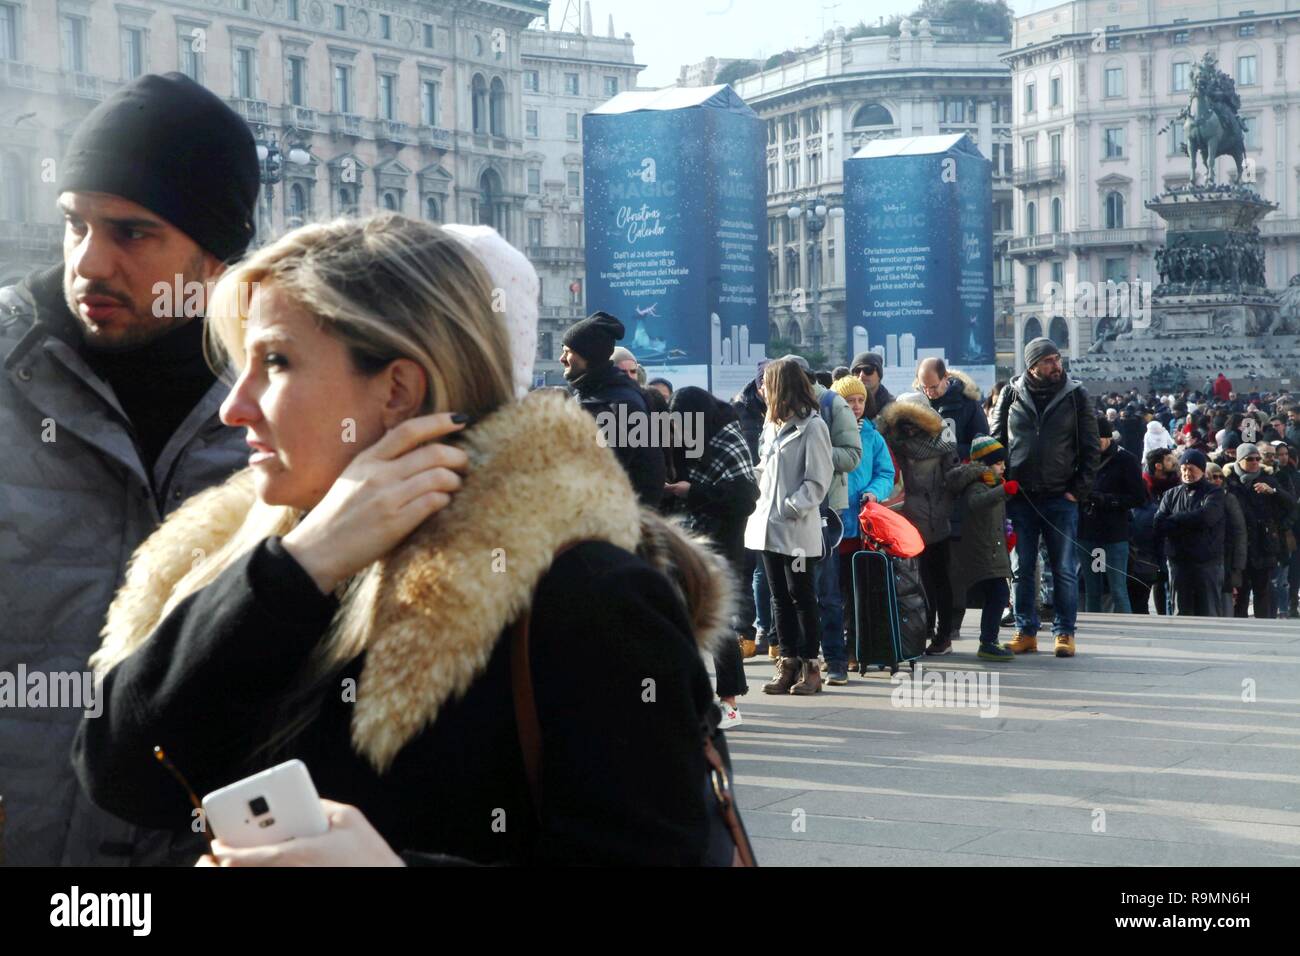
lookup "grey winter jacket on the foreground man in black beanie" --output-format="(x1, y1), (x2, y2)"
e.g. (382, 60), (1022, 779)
(0, 270), (248, 865)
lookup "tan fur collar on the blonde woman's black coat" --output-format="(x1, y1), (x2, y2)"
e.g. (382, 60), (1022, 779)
(92, 392), (735, 773)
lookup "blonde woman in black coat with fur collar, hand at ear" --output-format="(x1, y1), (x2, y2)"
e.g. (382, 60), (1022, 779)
(74, 213), (731, 865)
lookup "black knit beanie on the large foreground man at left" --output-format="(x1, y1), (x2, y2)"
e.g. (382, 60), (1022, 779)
(60, 73), (259, 260)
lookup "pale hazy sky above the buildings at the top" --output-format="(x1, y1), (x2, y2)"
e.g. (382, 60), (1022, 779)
(564, 0), (1060, 87)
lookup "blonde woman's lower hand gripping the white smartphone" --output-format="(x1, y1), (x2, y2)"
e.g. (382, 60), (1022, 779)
(195, 800), (406, 866)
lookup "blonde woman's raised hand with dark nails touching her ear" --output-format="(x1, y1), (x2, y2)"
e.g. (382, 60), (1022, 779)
(282, 412), (469, 594)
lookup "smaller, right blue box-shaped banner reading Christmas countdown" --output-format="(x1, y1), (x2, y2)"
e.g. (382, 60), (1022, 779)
(844, 134), (996, 390)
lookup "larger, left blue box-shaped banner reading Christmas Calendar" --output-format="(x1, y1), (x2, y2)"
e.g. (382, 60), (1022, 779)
(582, 86), (767, 398)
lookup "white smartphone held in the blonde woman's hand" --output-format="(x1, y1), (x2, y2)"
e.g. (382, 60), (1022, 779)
(203, 760), (329, 847)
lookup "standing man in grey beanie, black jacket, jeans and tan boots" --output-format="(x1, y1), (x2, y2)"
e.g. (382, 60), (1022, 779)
(992, 338), (1101, 657)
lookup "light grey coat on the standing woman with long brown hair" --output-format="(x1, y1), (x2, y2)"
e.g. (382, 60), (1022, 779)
(745, 412), (832, 559)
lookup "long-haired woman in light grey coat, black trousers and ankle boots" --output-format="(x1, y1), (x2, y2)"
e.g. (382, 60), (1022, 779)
(745, 359), (832, 695)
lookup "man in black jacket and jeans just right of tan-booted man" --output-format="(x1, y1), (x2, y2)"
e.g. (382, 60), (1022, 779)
(1079, 416), (1147, 614)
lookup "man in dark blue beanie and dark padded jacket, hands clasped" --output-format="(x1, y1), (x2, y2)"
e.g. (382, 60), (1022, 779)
(1156, 449), (1223, 618)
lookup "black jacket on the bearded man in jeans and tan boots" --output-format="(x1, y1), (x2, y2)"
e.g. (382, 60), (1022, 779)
(991, 373), (1101, 501)
